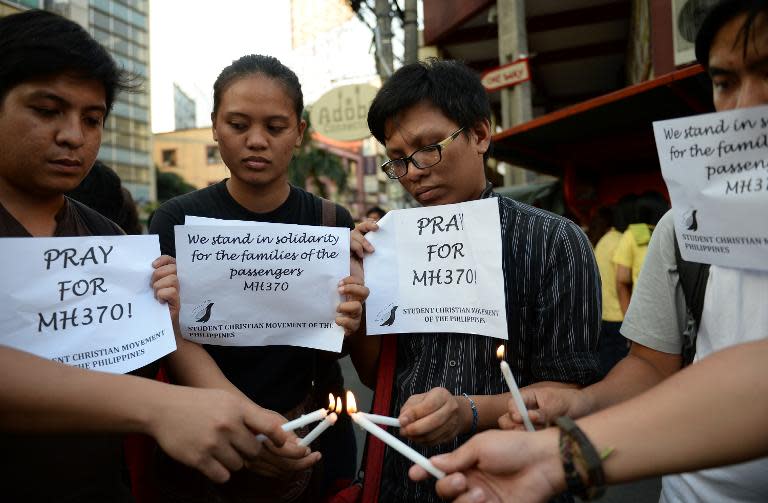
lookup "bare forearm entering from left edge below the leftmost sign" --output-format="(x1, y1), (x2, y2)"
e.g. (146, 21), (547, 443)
(0, 347), (166, 433)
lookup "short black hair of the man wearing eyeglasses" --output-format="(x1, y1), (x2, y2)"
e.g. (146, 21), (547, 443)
(368, 58), (491, 145)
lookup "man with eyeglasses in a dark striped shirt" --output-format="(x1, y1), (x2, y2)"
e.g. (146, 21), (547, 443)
(353, 60), (600, 502)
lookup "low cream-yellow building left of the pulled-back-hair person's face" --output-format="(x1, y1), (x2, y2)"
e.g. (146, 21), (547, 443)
(152, 127), (229, 189)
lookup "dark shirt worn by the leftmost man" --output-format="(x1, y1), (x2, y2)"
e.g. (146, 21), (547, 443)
(0, 198), (135, 503)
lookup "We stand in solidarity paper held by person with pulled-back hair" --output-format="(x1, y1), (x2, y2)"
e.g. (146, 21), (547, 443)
(175, 218), (349, 352)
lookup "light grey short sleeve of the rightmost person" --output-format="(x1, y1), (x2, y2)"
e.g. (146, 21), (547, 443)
(621, 210), (686, 354)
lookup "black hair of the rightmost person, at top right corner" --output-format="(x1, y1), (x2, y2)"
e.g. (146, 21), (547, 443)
(696, 0), (768, 68)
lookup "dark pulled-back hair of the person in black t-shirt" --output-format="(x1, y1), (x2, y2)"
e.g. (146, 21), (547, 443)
(211, 54), (304, 121)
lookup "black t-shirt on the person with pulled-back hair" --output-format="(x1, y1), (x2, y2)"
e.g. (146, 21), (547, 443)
(149, 180), (353, 412)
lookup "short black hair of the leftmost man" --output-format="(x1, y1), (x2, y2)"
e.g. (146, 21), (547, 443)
(0, 10), (135, 112)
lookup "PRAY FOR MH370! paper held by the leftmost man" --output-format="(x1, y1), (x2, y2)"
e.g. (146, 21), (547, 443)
(0, 236), (176, 373)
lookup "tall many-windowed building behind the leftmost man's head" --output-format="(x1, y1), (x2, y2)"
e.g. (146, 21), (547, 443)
(0, 0), (155, 202)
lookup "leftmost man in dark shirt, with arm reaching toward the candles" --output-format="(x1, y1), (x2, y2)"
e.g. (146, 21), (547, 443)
(0, 11), (286, 503)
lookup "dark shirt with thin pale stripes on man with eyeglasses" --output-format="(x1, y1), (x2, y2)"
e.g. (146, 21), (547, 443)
(380, 189), (600, 503)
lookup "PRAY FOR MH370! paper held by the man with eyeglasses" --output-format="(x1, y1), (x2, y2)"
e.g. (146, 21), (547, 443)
(364, 198), (507, 339)
